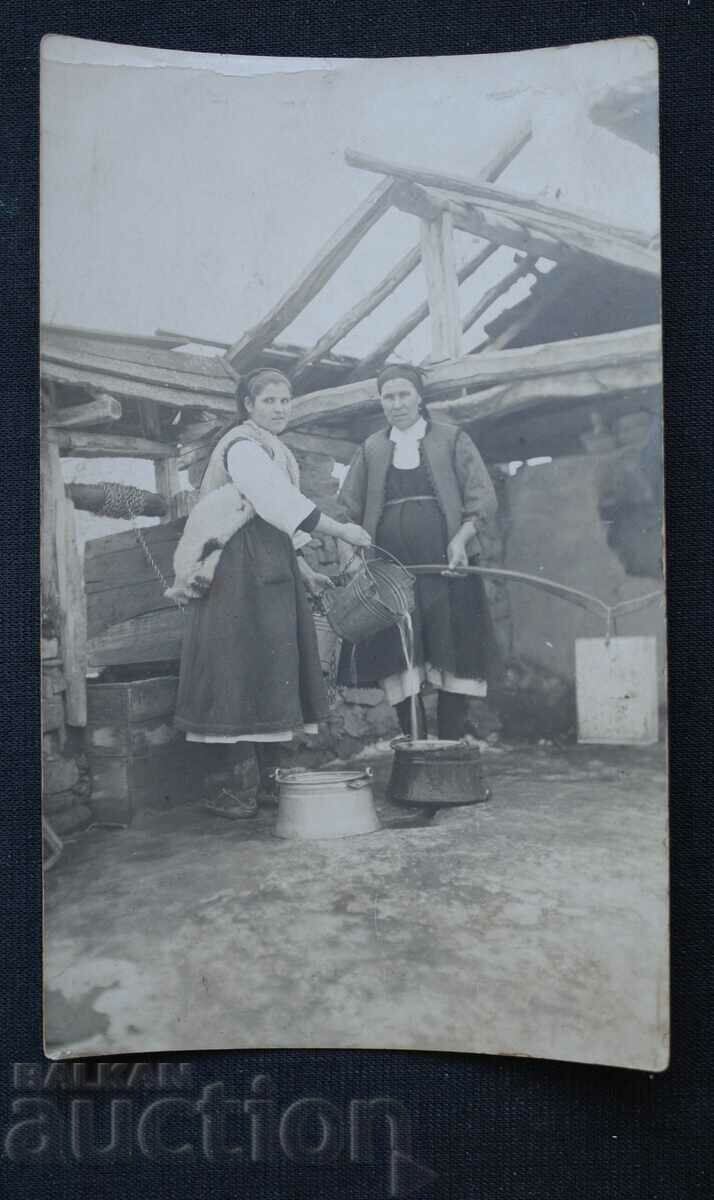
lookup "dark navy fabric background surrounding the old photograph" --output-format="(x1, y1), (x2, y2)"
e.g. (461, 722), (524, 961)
(0, 0), (714, 1200)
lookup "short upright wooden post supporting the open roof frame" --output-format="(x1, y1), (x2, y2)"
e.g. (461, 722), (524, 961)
(421, 212), (463, 362)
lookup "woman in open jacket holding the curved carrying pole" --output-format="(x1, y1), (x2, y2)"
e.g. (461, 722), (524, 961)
(338, 365), (497, 739)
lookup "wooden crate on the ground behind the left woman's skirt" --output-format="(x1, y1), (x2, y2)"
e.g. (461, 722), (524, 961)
(85, 676), (202, 824)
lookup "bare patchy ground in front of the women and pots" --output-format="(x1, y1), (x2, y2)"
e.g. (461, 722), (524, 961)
(46, 745), (668, 1070)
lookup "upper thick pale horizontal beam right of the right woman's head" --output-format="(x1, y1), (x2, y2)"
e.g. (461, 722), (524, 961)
(426, 325), (661, 397)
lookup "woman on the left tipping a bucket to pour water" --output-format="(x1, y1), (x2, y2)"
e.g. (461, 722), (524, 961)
(172, 370), (370, 816)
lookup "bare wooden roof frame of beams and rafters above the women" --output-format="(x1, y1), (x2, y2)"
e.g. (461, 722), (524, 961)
(41, 104), (661, 724)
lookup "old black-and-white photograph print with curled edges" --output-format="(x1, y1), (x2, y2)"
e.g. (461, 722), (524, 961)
(40, 36), (670, 1072)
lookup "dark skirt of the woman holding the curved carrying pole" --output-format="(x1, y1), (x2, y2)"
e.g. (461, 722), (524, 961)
(337, 500), (498, 688)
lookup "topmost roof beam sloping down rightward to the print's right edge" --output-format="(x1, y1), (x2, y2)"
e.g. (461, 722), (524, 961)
(346, 150), (660, 275)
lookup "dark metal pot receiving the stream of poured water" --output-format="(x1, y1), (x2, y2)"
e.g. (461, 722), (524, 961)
(389, 738), (491, 809)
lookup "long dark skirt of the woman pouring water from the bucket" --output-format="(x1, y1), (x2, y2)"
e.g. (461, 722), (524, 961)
(175, 516), (328, 737)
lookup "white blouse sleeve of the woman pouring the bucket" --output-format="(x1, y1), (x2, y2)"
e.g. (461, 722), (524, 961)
(226, 439), (314, 536)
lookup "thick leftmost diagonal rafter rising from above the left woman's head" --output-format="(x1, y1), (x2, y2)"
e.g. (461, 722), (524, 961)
(227, 180), (391, 370)
